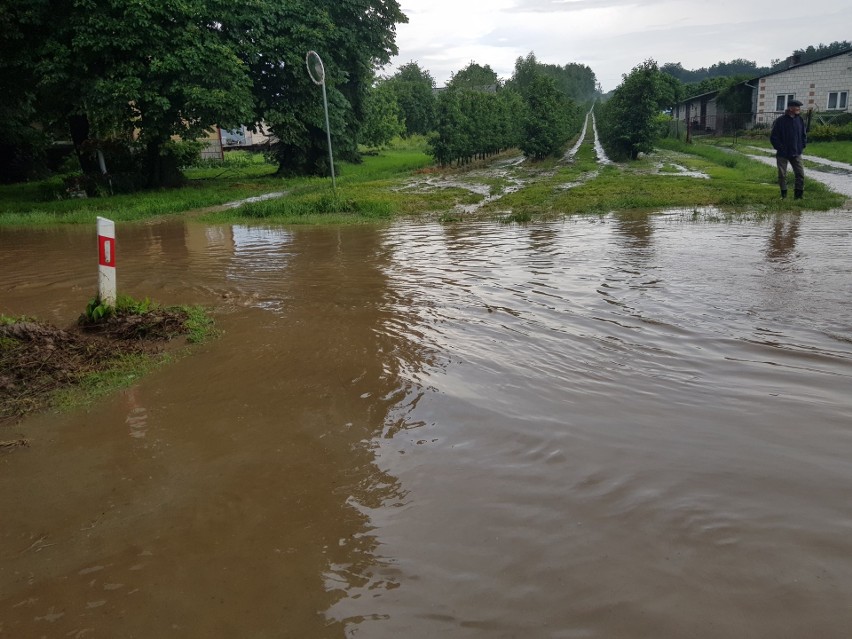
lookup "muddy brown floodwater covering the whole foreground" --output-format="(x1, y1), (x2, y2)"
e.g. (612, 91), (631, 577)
(0, 211), (852, 639)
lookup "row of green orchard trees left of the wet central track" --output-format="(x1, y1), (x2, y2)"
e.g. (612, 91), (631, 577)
(362, 53), (598, 165)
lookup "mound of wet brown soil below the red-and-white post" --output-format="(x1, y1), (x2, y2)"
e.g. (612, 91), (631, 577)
(0, 308), (194, 430)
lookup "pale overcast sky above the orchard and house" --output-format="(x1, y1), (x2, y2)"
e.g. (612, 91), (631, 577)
(384, 0), (852, 91)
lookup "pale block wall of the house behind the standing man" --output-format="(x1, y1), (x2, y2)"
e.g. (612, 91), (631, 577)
(756, 52), (852, 122)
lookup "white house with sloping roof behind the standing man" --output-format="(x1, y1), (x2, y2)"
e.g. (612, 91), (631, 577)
(748, 49), (852, 124)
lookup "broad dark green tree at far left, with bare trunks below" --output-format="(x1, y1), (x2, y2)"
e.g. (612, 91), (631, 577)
(5, 0), (252, 186)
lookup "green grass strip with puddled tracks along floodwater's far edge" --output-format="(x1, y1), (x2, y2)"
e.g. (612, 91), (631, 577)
(0, 136), (848, 225)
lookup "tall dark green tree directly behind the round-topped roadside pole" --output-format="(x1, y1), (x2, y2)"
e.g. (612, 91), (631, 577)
(252, 0), (407, 174)
